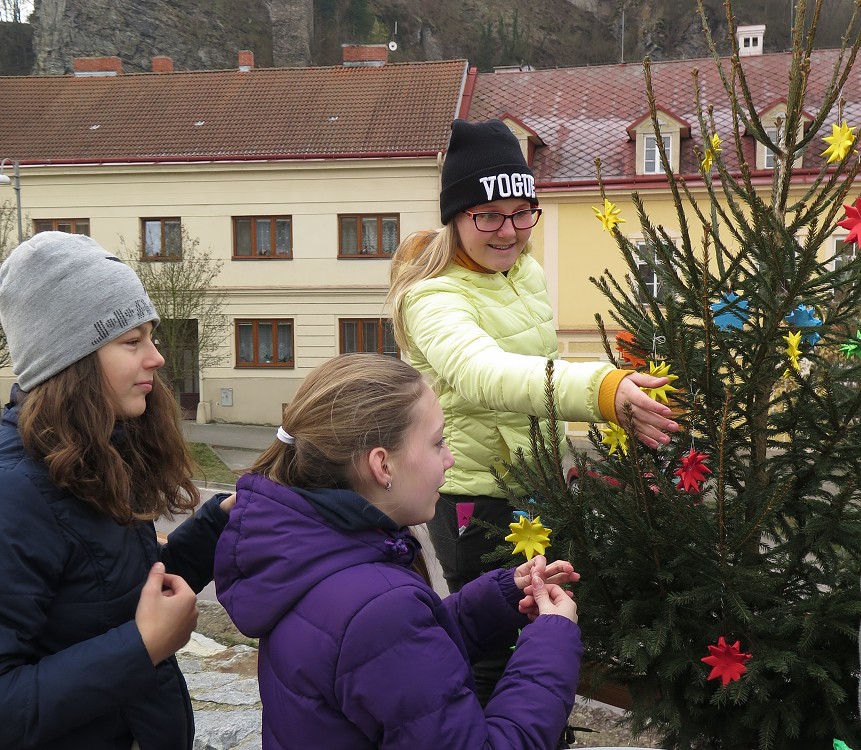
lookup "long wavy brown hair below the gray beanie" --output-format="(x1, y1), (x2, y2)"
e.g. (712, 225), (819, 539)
(18, 352), (200, 523)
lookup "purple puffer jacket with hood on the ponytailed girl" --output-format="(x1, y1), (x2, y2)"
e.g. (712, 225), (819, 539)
(215, 474), (582, 750)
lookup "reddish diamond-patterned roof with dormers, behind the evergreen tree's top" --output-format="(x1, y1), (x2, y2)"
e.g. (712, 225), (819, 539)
(469, 50), (861, 188)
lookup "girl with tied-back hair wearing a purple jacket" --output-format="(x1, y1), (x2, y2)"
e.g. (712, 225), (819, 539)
(215, 354), (582, 750)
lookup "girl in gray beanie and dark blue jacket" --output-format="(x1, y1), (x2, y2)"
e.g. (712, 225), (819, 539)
(0, 232), (235, 750)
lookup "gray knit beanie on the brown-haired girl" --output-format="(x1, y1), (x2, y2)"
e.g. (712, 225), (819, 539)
(0, 232), (159, 391)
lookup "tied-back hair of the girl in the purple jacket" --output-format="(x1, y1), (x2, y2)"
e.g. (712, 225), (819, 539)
(250, 354), (430, 583)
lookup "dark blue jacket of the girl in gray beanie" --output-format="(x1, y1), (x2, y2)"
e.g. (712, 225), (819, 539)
(0, 396), (227, 750)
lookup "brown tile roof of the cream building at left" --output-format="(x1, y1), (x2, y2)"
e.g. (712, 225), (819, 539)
(0, 60), (467, 163)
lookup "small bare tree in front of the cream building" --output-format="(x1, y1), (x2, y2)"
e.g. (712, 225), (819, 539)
(121, 229), (229, 406)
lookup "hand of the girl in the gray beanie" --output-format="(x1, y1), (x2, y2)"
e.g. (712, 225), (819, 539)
(135, 562), (197, 664)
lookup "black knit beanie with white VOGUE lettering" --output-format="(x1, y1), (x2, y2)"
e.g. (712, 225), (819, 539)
(439, 120), (538, 224)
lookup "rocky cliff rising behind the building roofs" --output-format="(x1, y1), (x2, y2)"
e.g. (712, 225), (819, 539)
(5, 0), (853, 75)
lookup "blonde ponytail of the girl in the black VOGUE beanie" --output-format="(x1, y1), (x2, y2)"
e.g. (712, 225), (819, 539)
(386, 226), (460, 352)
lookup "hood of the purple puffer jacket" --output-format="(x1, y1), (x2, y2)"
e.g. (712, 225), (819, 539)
(215, 474), (420, 638)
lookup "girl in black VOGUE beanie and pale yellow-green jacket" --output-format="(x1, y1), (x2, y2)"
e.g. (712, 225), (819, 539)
(388, 120), (678, 703)
